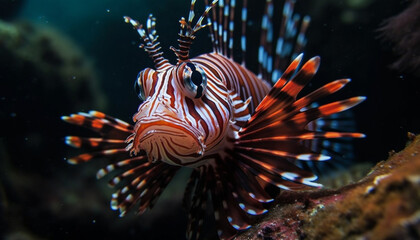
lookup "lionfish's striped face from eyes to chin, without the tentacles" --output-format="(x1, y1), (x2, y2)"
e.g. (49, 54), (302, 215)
(128, 62), (217, 165)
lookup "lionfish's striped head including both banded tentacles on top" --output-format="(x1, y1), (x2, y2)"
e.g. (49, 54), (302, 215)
(125, 1), (229, 165)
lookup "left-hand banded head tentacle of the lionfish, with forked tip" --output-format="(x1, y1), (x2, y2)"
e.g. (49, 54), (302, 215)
(124, 14), (171, 71)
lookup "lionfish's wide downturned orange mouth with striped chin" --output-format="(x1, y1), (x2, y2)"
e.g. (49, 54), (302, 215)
(127, 117), (205, 166)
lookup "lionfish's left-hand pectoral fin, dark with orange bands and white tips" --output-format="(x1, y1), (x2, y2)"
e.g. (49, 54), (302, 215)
(62, 111), (178, 216)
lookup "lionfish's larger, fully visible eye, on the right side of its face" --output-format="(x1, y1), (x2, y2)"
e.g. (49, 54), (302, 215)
(183, 62), (207, 98)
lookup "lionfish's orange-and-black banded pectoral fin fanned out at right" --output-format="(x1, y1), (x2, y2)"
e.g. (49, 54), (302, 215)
(231, 55), (365, 190)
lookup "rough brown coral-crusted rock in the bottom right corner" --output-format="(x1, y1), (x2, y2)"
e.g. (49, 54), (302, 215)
(237, 136), (420, 239)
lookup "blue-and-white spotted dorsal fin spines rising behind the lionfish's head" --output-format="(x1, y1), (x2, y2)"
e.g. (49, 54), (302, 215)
(205, 0), (310, 84)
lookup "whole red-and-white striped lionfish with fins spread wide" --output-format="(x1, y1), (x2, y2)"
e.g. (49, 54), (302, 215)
(62, 0), (365, 239)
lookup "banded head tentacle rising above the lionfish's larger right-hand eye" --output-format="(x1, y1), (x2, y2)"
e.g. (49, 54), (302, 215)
(171, 0), (218, 63)
